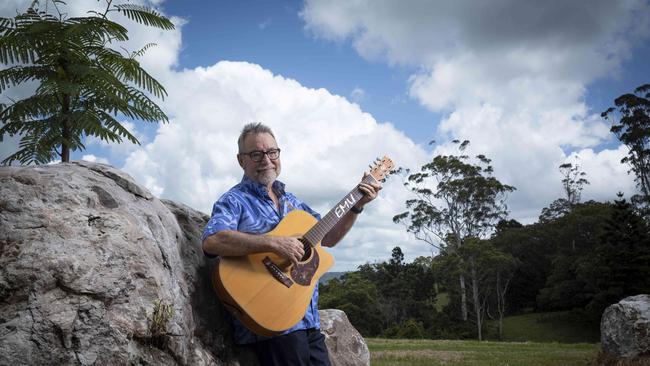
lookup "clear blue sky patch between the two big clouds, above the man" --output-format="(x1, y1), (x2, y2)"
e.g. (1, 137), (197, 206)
(163, 1), (440, 143)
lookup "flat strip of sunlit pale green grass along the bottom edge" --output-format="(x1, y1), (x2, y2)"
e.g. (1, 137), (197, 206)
(366, 338), (600, 366)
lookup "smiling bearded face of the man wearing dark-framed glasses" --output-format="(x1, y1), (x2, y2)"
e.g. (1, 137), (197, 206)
(237, 133), (281, 187)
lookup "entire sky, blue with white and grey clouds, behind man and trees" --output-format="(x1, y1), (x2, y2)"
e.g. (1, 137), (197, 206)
(0, 0), (650, 271)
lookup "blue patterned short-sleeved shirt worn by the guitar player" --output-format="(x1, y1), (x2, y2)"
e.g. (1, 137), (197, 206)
(201, 176), (320, 344)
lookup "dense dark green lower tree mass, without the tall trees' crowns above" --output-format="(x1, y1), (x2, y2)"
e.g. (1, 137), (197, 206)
(320, 183), (650, 339)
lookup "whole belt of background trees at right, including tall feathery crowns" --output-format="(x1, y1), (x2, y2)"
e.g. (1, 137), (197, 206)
(320, 84), (650, 340)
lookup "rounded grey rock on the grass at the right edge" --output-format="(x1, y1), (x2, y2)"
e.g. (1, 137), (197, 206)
(600, 295), (650, 361)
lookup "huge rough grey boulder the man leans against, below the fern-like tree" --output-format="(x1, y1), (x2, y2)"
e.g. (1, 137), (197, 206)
(0, 162), (364, 366)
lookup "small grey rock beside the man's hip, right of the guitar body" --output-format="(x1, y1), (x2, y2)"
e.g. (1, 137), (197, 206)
(319, 309), (370, 366)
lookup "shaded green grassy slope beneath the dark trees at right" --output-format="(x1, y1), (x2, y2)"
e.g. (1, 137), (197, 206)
(487, 311), (600, 343)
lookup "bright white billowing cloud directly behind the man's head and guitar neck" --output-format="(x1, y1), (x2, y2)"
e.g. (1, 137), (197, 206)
(123, 61), (428, 269)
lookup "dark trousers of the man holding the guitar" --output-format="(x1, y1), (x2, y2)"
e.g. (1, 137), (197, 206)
(252, 329), (330, 366)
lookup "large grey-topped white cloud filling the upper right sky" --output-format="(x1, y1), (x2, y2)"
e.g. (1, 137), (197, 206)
(301, 0), (650, 222)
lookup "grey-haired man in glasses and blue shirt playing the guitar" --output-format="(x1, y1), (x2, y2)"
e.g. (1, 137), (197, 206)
(203, 123), (381, 366)
